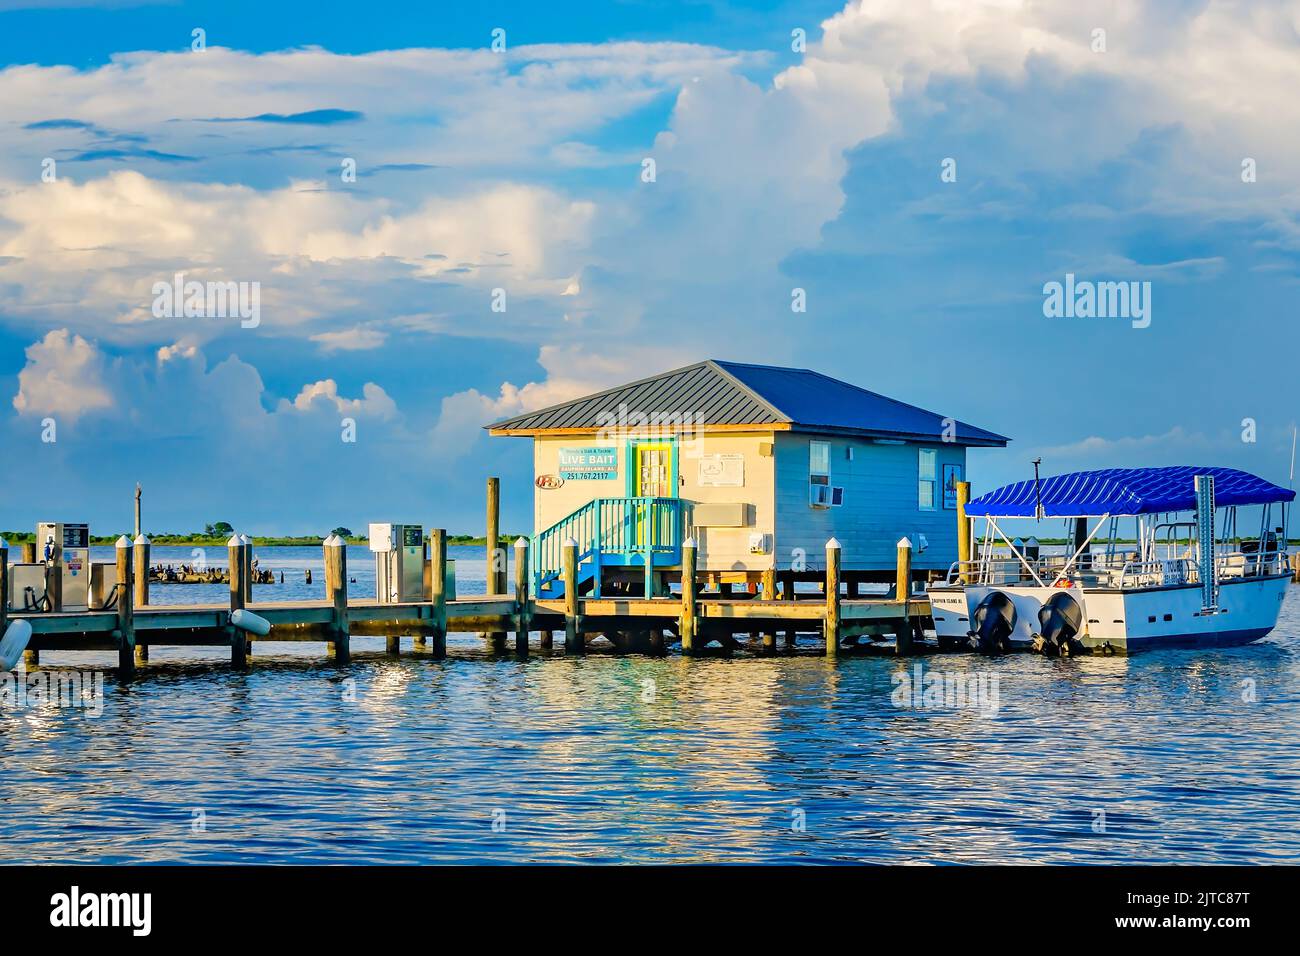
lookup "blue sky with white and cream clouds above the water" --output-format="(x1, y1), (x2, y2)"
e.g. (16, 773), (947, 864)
(0, 0), (1300, 535)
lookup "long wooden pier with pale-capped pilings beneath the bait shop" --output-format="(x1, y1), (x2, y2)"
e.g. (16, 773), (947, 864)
(0, 529), (930, 675)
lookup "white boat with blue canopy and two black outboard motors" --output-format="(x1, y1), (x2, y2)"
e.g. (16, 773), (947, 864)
(927, 466), (1295, 654)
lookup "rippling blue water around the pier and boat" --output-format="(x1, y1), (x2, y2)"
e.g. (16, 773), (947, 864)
(0, 549), (1300, 864)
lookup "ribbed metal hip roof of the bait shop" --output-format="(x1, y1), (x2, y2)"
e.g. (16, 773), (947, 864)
(486, 359), (1009, 446)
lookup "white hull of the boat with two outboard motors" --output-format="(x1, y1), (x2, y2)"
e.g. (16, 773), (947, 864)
(928, 575), (1291, 653)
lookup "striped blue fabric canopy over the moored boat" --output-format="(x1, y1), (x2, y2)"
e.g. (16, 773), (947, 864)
(966, 464), (1296, 518)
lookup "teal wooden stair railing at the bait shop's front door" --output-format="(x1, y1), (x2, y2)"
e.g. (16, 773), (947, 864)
(528, 498), (683, 600)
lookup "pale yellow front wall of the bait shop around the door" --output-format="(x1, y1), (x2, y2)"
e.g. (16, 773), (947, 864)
(533, 432), (776, 571)
